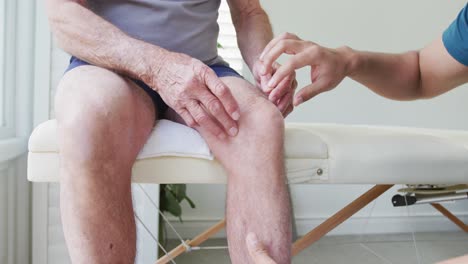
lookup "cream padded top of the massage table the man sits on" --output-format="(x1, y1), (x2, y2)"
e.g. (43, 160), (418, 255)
(28, 120), (468, 184)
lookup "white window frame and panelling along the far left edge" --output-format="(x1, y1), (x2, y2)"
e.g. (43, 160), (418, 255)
(0, 0), (35, 264)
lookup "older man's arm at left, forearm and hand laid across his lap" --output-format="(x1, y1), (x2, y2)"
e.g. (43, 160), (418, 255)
(47, 0), (239, 138)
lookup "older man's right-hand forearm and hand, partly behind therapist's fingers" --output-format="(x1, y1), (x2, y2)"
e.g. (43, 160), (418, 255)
(228, 0), (297, 115)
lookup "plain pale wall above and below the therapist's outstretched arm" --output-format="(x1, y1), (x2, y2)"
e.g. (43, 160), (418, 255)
(264, 0), (468, 129)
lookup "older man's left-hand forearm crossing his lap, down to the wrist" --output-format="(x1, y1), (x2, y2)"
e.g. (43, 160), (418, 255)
(48, 0), (167, 80)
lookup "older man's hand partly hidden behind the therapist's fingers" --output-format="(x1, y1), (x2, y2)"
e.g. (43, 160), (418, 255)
(252, 60), (297, 117)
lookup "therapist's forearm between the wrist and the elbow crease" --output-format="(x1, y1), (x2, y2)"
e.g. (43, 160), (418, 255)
(341, 47), (421, 100)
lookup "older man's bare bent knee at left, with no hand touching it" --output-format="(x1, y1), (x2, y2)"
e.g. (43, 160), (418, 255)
(55, 66), (141, 163)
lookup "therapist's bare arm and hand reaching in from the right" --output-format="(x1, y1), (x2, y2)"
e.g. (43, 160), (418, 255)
(262, 33), (468, 104)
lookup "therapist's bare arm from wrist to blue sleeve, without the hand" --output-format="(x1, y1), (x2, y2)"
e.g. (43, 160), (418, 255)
(345, 37), (468, 100)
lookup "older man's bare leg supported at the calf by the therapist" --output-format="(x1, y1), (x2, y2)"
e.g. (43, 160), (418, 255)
(170, 77), (291, 264)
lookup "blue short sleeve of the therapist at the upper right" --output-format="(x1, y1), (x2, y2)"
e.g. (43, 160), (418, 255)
(442, 4), (468, 66)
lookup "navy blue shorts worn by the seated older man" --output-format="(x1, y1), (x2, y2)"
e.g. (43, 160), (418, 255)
(65, 56), (242, 115)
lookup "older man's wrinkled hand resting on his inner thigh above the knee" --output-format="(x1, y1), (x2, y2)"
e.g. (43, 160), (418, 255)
(153, 52), (240, 139)
